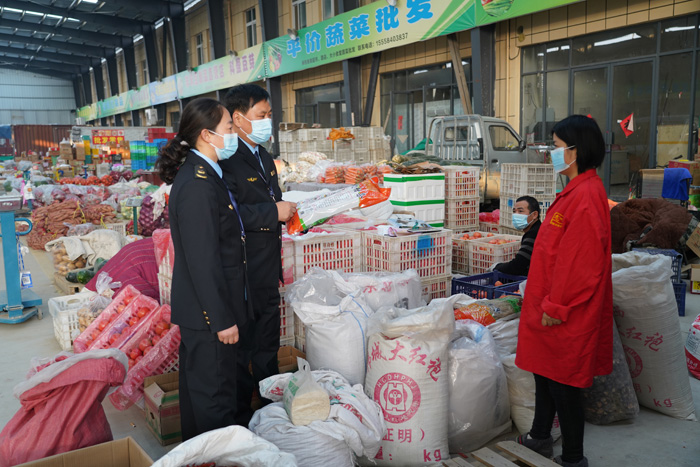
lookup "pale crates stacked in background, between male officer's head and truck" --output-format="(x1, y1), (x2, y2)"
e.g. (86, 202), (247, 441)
(279, 127), (391, 164)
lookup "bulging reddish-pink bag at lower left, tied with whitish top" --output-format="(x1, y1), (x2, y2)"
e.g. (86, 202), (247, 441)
(0, 349), (126, 467)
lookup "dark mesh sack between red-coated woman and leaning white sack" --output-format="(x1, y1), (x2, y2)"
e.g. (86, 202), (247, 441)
(581, 328), (639, 425)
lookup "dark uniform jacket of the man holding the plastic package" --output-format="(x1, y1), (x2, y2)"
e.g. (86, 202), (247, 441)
(219, 139), (282, 288)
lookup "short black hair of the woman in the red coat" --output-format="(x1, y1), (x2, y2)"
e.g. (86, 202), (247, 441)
(552, 115), (605, 174)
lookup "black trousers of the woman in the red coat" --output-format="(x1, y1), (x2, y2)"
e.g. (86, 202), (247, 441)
(530, 375), (585, 462)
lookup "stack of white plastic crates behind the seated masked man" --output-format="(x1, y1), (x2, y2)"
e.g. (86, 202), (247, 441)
(499, 164), (557, 235)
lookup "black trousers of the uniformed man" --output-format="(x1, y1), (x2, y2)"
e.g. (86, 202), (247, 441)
(238, 287), (280, 414)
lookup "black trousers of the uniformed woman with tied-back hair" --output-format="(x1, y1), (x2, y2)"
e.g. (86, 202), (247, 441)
(180, 327), (250, 441)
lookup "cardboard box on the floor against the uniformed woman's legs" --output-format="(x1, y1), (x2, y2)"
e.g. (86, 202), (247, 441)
(143, 371), (182, 446)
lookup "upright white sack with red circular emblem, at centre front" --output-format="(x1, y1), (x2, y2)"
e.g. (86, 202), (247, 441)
(365, 299), (455, 466)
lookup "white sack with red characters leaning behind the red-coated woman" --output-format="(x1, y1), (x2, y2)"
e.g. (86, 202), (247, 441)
(612, 251), (696, 420)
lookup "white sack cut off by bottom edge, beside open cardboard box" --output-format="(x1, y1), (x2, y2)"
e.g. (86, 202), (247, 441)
(152, 425), (297, 467)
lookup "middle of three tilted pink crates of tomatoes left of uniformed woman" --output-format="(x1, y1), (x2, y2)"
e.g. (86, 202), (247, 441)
(74, 295), (160, 352)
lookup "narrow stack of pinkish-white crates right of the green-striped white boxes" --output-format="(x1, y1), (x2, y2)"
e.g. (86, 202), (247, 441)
(443, 165), (479, 233)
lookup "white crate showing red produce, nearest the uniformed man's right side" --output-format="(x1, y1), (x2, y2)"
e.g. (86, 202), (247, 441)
(293, 229), (362, 279)
